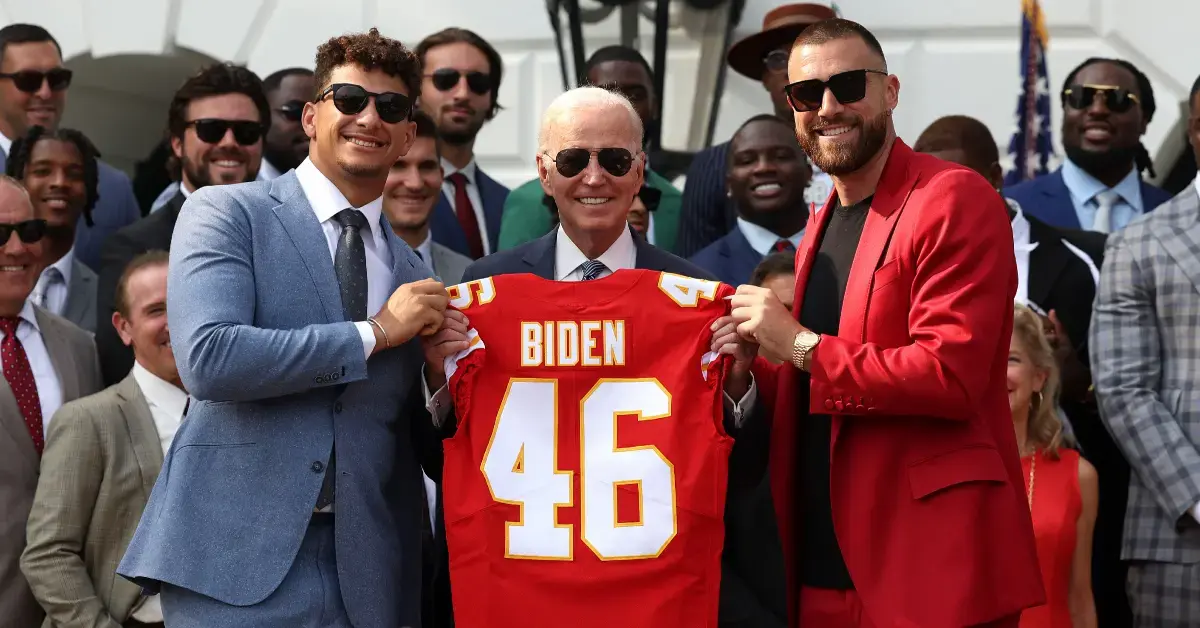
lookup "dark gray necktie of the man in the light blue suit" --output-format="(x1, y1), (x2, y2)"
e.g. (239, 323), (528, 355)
(317, 209), (367, 510)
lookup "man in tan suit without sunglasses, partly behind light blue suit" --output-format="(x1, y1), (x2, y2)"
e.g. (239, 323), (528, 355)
(20, 251), (187, 628)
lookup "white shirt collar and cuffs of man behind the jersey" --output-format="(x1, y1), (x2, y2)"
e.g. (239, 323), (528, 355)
(421, 227), (758, 425)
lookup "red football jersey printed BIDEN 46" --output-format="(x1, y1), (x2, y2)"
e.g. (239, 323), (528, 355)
(443, 270), (733, 628)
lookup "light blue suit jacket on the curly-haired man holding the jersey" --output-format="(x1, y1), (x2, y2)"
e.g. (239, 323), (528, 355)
(118, 172), (440, 628)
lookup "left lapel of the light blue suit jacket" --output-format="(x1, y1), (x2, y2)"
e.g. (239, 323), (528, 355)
(271, 171), (346, 323)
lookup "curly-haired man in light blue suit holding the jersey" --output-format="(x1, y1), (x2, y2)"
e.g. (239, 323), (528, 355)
(118, 29), (448, 628)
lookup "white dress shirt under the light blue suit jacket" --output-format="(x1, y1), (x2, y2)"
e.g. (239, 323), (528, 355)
(296, 159), (391, 355)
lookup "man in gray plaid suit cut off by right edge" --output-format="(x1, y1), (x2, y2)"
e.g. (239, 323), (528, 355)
(1091, 72), (1200, 627)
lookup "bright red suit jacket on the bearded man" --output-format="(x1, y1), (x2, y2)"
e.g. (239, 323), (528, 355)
(755, 139), (1044, 628)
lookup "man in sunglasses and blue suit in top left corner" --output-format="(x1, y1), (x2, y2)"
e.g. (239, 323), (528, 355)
(0, 24), (142, 271)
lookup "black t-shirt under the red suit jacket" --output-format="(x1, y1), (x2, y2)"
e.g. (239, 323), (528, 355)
(796, 197), (872, 590)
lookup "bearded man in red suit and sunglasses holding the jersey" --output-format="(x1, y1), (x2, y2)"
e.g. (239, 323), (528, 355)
(714, 19), (1044, 628)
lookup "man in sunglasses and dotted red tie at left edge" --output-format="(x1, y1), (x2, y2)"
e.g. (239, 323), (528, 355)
(0, 175), (101, 628)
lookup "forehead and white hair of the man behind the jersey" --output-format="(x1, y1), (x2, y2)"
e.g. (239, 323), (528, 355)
(538, 86), (642, 155)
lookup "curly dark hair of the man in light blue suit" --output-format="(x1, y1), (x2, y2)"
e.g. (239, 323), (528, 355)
(313, 29), (421, 110)
